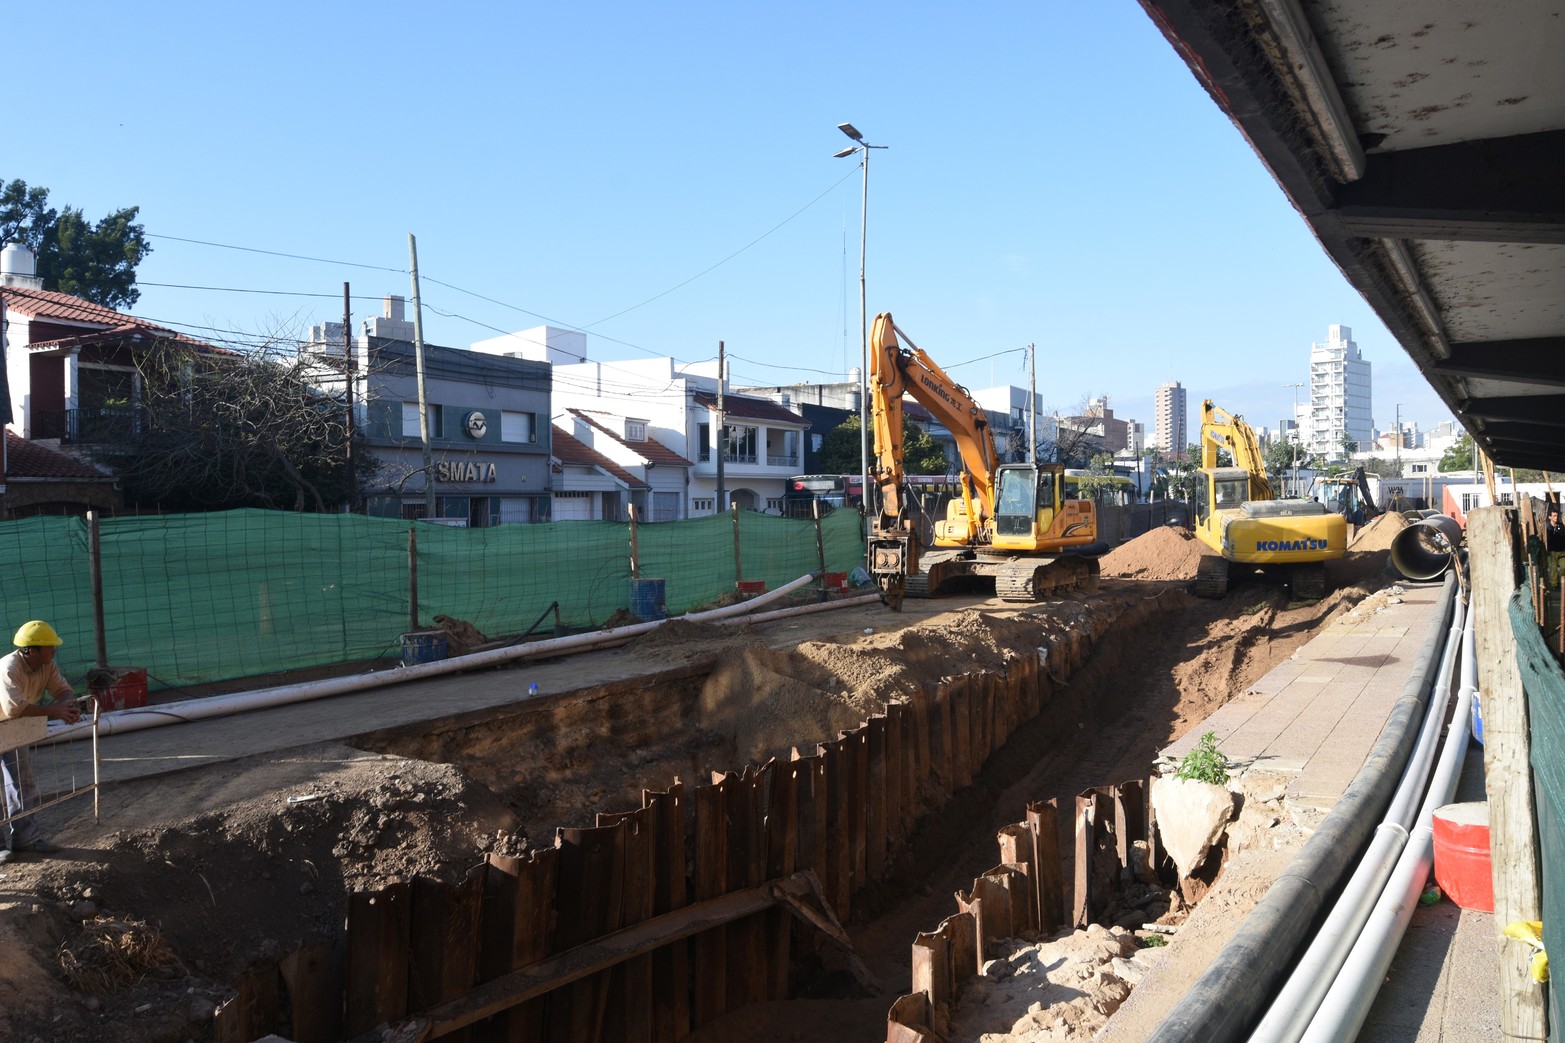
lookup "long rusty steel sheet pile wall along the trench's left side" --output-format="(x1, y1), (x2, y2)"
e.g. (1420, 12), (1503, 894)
(208, 620), (1089, 1043)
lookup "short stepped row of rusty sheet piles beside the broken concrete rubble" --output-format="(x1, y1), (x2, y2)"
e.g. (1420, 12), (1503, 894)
(886, 780), (1161, 1043)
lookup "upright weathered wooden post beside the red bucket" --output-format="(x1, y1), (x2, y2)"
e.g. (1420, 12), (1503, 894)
(1466, 507), (1546, 1040)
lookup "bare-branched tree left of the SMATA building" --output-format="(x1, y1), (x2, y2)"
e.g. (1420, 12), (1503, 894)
(110, 337), (374, 511)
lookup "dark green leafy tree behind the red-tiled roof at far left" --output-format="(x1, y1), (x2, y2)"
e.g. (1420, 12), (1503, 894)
(0, 180), (152, 309)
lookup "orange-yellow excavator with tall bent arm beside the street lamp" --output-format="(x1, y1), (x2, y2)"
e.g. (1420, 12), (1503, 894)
(869, 313), (1108, 609)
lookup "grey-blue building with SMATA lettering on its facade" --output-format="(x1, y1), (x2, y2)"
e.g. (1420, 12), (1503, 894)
(302, 296), (554, 528)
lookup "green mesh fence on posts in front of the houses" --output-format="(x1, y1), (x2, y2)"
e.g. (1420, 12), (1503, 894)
(0, 511), (862, 689)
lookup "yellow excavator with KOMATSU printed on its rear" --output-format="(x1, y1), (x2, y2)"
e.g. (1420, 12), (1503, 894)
(1193, 398), (1347, 600)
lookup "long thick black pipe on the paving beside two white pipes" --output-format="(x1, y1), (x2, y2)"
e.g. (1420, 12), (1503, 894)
(1149, 572), (1457, 1043)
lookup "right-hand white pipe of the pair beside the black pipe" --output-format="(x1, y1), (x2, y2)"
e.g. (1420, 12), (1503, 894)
(1301, 601), (1477, 1043)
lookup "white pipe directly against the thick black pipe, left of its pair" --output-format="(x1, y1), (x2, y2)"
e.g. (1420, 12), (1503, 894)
(1250, 588), (1466, 1043)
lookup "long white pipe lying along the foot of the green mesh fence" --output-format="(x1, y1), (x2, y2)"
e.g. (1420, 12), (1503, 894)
(44, 573), (881, 742)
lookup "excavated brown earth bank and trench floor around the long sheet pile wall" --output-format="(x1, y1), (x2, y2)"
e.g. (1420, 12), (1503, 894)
(345, 563), (1383, 1040)
